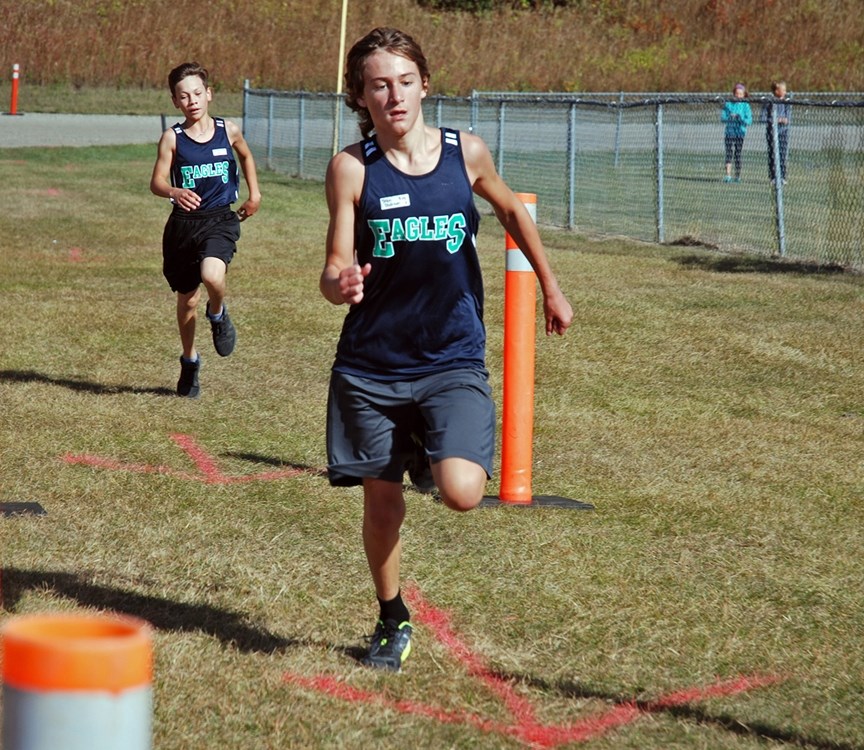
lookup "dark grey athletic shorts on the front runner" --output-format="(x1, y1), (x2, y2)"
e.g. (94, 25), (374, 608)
(327, 369), (495, 487)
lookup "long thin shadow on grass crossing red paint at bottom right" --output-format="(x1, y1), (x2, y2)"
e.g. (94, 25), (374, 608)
(510, 673), (864, 750)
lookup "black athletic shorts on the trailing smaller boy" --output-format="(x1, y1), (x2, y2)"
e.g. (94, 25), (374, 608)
(162, 206), (240, 294)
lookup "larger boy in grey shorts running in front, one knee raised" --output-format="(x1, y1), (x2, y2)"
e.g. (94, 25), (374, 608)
(320, 29), (573, 671)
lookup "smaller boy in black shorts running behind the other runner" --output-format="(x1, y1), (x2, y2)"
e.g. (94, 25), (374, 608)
(150, 62), (261, 398)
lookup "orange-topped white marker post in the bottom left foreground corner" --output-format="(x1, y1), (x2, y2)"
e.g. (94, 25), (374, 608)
(0, 614), (153, 750)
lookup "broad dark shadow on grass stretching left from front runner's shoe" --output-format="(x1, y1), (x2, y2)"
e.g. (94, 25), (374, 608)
(0, 568), (363, 661)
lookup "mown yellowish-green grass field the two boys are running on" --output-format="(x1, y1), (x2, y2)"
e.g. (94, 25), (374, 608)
(0, 146), (864, 750)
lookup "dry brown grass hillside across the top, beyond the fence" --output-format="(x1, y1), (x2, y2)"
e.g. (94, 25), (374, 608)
(0, 0), (864, 94)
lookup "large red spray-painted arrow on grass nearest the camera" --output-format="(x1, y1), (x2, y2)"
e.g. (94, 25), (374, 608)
(284, 585), (783, 748)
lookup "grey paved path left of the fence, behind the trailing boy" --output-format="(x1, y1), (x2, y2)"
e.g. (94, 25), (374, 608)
(0, 112), (243, 148)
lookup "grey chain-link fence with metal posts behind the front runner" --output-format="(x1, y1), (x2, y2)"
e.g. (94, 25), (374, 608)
(243, 88), (864, 270)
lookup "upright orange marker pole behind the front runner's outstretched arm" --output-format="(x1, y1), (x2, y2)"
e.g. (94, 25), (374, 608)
(498, 193), (537, 504)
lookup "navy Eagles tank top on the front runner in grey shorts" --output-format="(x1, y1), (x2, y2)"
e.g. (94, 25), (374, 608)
(333, 129), (486, 380)
